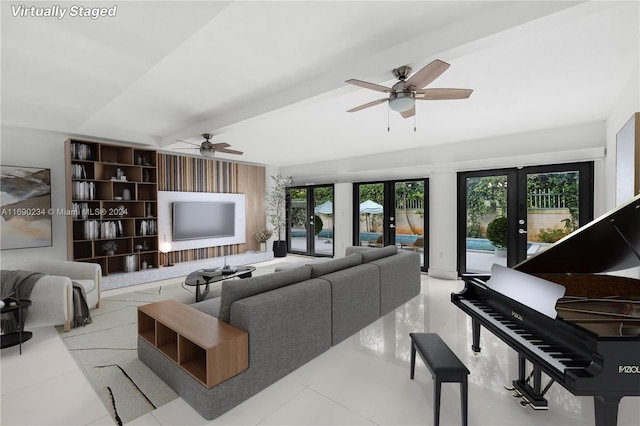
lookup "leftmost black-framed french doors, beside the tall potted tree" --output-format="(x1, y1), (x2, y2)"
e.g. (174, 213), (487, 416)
(287, 185), (333, 257)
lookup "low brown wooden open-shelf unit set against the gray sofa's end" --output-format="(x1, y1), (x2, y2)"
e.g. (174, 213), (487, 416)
(138, 300), (249, 388)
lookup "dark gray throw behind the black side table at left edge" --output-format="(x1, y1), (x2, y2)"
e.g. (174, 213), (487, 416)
(0, 270), (44, 333)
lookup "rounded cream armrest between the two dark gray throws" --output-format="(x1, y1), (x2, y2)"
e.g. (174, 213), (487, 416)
(25, 275), (73, 331)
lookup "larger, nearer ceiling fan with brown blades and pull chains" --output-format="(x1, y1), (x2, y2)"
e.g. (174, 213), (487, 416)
(345, 59), (473, 118)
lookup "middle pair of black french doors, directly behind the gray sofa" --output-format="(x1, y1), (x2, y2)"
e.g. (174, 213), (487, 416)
(353, 179), (429, 270)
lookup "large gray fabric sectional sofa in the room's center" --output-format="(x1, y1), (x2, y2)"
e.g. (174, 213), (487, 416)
(138, 246), (420, 420)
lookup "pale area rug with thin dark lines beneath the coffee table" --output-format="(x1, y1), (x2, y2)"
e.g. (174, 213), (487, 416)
(58, 267), (274, 425)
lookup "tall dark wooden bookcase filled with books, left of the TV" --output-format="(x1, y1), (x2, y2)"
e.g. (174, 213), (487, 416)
(65, 139), (158, 275)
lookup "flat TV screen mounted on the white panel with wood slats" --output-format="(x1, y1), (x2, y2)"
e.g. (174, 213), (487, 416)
(173, 201), (236, 241)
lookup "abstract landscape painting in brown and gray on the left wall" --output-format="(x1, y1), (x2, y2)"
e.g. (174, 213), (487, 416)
(0, 166), (52, 250)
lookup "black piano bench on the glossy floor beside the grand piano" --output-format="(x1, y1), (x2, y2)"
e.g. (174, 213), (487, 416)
(409, 333), (469, 426)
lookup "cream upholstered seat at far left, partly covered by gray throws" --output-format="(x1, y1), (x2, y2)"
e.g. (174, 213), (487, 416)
(2, 259), (102, 331)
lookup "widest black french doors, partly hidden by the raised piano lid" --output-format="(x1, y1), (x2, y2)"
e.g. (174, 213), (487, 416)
(458, 162), (593, 273)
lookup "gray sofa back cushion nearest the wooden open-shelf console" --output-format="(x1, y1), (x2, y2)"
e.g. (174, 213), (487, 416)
(218, 266), (311, 323)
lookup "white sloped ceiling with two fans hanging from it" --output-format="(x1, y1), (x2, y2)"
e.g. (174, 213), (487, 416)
(1, 1), (640, 167)
